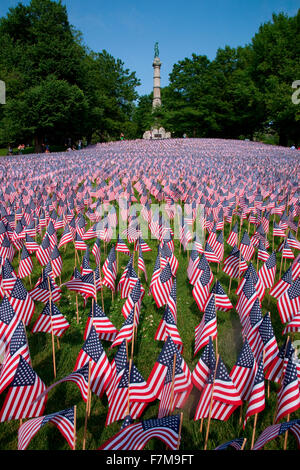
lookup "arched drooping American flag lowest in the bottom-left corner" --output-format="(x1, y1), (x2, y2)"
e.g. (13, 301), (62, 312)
(18, 408), (76, 450)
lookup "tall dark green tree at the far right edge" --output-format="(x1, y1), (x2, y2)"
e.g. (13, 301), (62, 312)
(250, 10), (300, 145)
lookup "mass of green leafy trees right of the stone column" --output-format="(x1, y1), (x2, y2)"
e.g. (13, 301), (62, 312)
(135, 10), (300, 145)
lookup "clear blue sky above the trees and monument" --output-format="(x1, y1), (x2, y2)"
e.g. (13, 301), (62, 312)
(0, 0), (299, 95)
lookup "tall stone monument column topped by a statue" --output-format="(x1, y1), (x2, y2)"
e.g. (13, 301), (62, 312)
(143, 42), (171, 140)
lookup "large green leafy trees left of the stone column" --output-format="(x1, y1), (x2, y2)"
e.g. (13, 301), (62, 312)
(0, 0), (139, 151)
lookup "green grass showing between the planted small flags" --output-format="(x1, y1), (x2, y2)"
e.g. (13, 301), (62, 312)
(0, 214), (300, 451)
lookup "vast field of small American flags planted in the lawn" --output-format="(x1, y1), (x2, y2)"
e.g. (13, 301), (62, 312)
(0, 139), (300, 451)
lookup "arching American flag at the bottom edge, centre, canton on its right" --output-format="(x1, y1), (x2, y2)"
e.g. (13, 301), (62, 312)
(99, 415), (180, 450)
